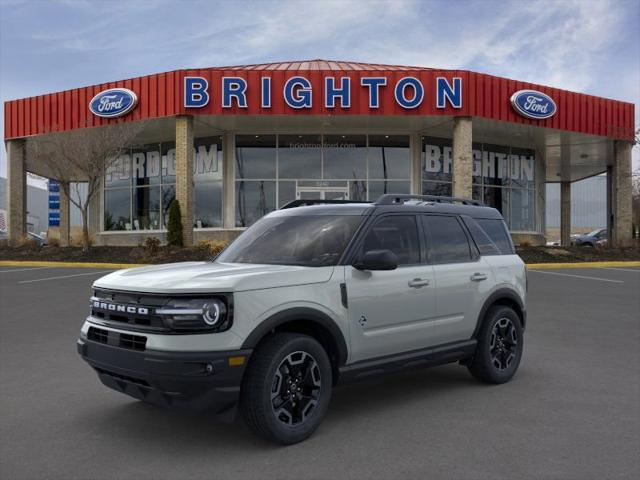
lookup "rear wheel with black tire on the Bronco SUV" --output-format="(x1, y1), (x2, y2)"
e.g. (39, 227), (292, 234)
(467, 305), (524, 383)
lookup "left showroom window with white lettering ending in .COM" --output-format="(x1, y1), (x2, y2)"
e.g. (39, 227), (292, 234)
(103, 136), (222, 231)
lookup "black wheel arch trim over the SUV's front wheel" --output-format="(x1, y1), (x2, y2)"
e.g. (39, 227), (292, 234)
(242, 307), (348, 366)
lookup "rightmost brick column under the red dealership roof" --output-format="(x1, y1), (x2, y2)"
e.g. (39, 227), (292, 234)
(609, 141), (633, 247)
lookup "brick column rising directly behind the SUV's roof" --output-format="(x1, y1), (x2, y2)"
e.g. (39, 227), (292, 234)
(453, 117), (473, 198)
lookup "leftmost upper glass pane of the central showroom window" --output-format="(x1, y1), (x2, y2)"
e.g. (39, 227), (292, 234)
(236, 135), (276, 179)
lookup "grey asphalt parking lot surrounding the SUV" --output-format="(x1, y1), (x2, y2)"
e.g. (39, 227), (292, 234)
(0, 267), (640, 480)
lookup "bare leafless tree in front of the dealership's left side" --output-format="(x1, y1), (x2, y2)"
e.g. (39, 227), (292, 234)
(27, 123), (142, 250)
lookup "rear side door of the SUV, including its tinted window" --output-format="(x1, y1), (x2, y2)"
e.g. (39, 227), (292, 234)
(422, 214), (493, 344)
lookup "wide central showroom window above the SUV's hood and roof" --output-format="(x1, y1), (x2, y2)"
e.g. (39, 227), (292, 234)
(235, 134), (411, 227)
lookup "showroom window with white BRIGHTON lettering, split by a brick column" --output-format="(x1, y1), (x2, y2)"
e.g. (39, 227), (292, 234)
(422, 137), (536, 232)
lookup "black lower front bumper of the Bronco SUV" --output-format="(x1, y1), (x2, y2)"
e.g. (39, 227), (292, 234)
(77, 338), (251, 415)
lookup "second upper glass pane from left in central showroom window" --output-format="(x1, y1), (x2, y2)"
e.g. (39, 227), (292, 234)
(278, 135), (322, 178)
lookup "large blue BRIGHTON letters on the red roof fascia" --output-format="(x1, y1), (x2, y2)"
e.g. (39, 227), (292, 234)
(183, 76), (462, 110)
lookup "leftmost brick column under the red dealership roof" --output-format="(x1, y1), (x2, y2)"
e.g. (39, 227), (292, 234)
(7, 139), (27, 245)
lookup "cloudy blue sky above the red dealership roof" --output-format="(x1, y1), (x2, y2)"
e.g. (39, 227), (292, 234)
(0, 0), (640, 183)
